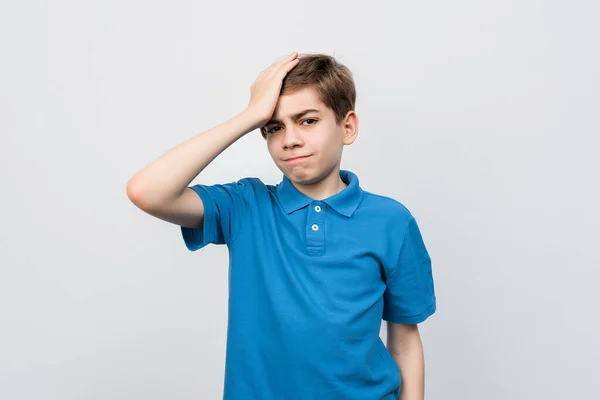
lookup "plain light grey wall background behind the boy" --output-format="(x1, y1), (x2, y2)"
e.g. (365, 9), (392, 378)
(0, 0), (600, 400)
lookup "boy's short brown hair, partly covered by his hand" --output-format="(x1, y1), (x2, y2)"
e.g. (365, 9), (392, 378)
(261, 53), (356, 137)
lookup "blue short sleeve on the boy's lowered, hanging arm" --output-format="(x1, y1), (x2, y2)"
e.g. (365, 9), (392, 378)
(382, 217), (436, 324)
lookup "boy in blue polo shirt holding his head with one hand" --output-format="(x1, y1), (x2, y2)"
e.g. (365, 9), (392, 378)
(127, 52), (436, 400)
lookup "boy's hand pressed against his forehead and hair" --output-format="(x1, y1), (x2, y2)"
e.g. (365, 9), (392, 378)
(246, 52), (298, 127)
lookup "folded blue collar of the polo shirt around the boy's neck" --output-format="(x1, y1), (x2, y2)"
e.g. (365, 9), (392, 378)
(277, 169), (363, 217)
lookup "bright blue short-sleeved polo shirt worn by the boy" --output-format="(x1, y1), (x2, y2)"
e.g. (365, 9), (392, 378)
(181, 170), (436, 400)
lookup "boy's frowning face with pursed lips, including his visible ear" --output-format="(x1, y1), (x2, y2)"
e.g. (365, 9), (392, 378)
(262, 87), (358, 185)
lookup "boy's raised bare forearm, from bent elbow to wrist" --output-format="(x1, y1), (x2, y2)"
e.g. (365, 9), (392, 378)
(127, 109), (260, 206)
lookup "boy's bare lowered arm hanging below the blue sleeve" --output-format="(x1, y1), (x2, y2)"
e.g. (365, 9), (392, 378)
(386, 321), (425, 400)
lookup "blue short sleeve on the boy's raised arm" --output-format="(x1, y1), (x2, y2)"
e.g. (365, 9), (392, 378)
(181, 178), (253, 251)
